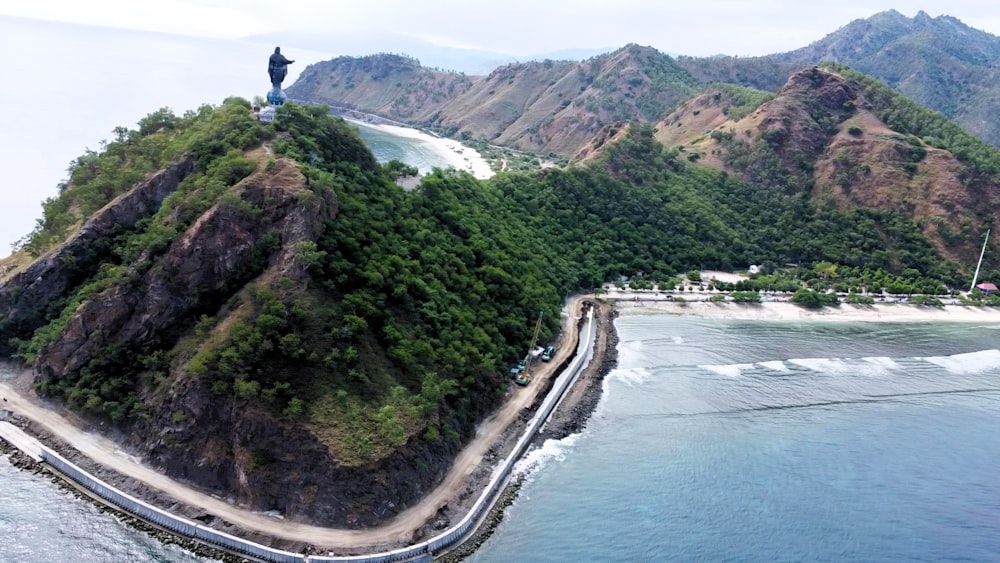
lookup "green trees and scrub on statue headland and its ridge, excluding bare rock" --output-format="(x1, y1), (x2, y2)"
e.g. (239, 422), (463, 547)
(3, 100), (984, 464)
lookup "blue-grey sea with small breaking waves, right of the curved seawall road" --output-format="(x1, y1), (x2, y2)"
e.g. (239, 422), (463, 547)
(473, 316), (1000, 563)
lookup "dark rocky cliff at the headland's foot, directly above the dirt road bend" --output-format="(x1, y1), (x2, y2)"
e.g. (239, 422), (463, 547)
(134, 380), (457, 528)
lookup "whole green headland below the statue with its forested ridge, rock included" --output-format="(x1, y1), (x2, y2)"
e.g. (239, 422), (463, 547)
(0, 99), (984, 526)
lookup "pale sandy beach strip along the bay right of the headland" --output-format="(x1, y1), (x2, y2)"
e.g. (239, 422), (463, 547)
(615, 295), (1000, 325)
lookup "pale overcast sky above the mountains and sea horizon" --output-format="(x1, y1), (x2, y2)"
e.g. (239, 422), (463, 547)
(0, 0), (1000, 55)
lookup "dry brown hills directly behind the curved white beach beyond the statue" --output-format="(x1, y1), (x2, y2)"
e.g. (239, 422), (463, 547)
(288, 45), (697, 156)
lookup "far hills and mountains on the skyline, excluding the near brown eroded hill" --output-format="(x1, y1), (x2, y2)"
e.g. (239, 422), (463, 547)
(290, 11), (1000, 150)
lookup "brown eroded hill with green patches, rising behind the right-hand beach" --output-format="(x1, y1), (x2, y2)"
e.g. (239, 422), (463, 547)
(656, 68), (1000, 261)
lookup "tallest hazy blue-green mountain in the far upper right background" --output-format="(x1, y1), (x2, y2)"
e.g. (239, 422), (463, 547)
(678, 10), (1000, 146)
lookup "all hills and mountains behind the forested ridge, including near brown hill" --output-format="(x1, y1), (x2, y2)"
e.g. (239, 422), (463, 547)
(288, 11), (1000, 268)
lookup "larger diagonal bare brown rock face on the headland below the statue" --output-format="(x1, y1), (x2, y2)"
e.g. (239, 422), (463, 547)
(35, 155), (336, 379)
